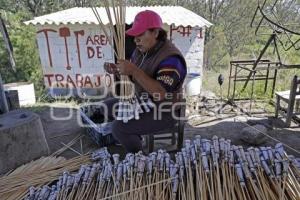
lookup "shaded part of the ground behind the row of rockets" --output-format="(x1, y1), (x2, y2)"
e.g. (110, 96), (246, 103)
(25, 106), (300, 158)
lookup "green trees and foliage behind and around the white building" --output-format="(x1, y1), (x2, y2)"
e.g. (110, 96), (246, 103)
(0, 0), (300, 102)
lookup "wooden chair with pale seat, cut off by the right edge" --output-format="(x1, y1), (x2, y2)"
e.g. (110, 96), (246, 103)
(275, 76), (300, 127)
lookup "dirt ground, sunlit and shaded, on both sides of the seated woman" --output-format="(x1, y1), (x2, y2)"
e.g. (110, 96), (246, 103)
(31, 96), (300, 158)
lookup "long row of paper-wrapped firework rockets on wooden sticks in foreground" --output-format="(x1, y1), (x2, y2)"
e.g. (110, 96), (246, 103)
(26, 136), (300, 200)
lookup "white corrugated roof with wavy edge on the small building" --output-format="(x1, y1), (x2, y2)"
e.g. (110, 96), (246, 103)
(24, 6), (212, 27)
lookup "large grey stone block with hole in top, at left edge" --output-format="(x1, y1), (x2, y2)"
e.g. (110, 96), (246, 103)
(0, 110), (49, 174)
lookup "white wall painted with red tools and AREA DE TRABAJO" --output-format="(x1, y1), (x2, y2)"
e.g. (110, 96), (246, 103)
(37, 25), (113, 96)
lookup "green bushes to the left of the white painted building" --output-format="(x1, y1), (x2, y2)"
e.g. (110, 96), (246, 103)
(0, 12), (43, 96)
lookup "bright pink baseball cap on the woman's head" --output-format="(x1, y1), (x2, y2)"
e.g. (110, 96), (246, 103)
(126, 10), (163, 36)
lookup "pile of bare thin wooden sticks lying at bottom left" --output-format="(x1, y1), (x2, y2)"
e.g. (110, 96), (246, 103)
(0, 154), (90, 200)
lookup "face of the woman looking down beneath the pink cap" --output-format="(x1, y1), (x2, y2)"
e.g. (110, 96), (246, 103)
(134, 30), (158, 53)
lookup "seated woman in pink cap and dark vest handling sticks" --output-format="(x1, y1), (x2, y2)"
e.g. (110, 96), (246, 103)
(105, 10), (186, 152)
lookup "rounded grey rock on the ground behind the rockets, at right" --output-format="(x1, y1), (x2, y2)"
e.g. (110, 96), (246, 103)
(241, 124), (267, 145)
